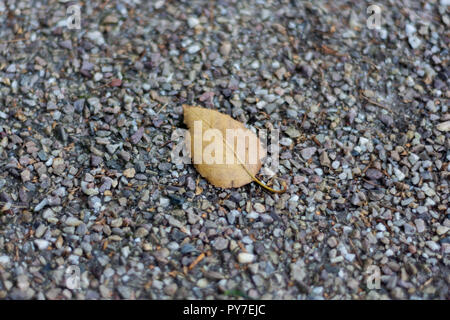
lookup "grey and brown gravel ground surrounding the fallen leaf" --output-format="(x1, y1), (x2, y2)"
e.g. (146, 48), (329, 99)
(0, 0), (450, 299)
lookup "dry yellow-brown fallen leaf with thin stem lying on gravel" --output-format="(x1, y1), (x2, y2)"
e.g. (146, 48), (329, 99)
(183, 105), (285, 192)
